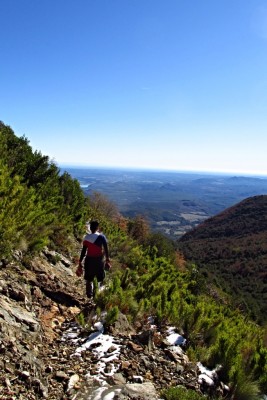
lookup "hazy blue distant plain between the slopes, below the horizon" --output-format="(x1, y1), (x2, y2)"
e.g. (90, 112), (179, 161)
(64, 167), (267, 239)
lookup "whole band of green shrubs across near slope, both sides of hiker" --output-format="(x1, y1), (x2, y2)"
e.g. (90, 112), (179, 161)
(0, 123), (267, 400)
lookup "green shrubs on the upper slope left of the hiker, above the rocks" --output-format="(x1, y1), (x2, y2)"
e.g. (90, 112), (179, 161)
(0, 123), (88, 257)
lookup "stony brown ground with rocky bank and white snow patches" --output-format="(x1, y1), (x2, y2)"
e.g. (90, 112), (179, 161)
(0, 250), (227, 400)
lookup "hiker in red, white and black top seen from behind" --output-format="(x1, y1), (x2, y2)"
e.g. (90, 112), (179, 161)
(76, 221), (110, 298)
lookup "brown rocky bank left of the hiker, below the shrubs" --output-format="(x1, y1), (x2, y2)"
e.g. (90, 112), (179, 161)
(0, 250), (83, 400)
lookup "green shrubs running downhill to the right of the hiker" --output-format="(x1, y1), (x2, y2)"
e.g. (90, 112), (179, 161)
(91, 216), (266, 400)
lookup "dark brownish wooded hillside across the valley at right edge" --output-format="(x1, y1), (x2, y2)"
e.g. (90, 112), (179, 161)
(178, 195), (267, 322)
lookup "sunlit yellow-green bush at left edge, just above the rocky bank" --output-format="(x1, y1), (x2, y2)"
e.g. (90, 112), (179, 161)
(0, 162), (54, 256)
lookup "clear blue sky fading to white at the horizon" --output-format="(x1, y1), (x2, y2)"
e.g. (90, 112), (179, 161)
(0, 0), (267, 175)
